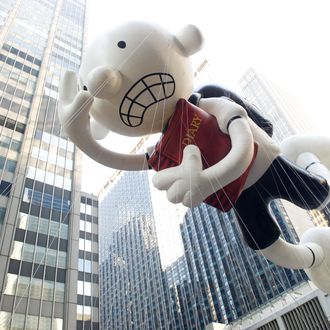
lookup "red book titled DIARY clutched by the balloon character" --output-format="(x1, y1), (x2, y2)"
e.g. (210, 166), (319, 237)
(148, 99), (257, 211)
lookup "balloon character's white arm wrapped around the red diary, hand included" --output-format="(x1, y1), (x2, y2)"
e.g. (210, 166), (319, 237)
(153, 99), (254, 207)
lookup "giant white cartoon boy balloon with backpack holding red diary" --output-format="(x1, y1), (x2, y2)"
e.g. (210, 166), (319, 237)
(59, 22), (330, 293)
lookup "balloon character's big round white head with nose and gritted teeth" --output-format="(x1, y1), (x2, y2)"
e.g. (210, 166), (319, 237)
(80, 22), (203, 136)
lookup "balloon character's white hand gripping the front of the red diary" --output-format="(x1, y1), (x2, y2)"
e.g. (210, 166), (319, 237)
(152, 145), (213, 207)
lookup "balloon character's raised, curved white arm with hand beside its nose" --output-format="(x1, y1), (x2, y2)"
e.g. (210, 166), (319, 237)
(58, 71), (148, 170)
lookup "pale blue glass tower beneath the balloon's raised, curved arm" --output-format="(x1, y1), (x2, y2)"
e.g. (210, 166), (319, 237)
(99, 171), (175, 329)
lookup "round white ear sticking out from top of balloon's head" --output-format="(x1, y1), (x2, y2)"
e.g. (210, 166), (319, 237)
(174, 24), (204, 56)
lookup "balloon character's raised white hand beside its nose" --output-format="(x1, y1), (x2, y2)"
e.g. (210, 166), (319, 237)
(58, 71), (94, 135)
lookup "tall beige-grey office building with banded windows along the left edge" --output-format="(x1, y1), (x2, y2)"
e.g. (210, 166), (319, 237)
(0, 0), (93, 329)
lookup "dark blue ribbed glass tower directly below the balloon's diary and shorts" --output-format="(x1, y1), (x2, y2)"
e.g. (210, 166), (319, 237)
(181, 204), (307, 329)
